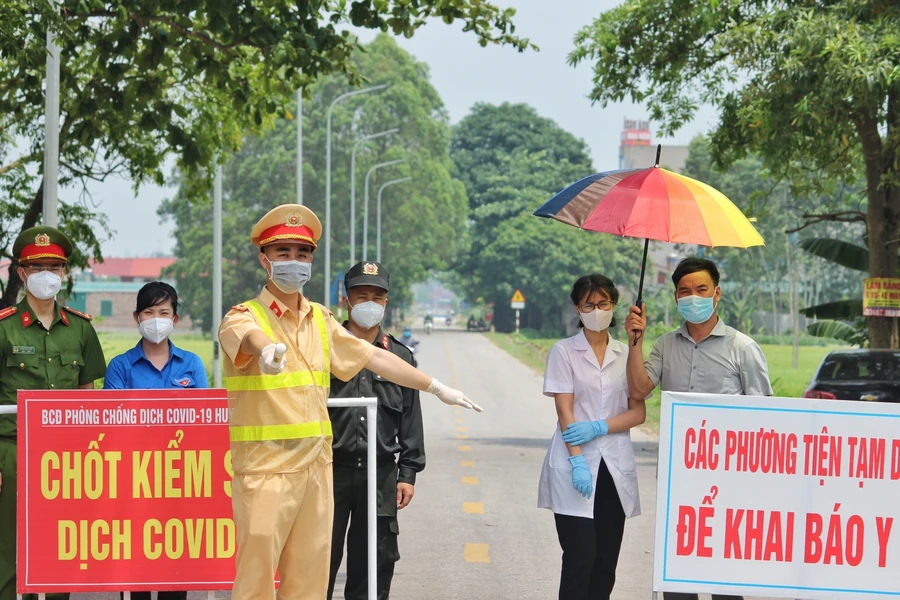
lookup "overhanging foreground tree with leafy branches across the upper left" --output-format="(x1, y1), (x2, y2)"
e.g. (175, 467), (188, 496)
(0, 0), (530, 305)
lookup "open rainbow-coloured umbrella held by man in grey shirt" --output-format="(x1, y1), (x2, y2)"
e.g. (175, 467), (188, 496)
(534, 146), (765, 330)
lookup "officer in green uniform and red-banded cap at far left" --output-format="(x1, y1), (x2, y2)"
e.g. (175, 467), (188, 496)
(0, 227), (106, 600)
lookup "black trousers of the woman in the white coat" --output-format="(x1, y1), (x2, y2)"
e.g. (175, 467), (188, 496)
(554, 461), (625, 600)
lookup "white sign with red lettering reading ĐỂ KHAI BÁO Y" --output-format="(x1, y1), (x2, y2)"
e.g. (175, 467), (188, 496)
(653, 392), (900, 600)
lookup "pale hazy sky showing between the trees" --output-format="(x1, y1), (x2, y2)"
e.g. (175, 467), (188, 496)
(84, 0), (717, 257)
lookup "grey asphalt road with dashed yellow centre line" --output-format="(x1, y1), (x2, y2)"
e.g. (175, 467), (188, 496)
(72, 327), (780, 600)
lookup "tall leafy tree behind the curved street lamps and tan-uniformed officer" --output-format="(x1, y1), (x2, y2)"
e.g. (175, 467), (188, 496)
(160, 34), (467, 331)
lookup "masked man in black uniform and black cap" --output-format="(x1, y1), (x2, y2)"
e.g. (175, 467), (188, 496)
(328, 262), (425, 600)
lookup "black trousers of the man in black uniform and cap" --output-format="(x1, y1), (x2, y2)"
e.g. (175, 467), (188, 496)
(328, 464), (400, 600)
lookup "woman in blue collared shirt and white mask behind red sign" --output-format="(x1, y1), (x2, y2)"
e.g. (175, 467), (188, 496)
(103, 281), (209, 600)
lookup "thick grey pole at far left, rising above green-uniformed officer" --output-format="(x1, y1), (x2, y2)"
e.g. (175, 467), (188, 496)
(43, 0), (59, 227)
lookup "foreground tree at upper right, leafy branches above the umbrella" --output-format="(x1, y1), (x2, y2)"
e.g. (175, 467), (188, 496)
(570, 0), (900, 348)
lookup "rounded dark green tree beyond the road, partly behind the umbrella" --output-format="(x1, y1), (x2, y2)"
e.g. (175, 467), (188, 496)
(452, 104), (641, 335)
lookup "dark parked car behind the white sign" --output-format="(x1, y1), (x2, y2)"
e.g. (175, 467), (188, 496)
(803, 350), (900, 402)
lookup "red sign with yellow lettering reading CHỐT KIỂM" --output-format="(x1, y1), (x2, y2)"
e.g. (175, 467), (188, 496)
(16, 390), (236, 593)
